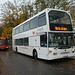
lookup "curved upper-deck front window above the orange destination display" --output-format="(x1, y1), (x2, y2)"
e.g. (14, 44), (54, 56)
(49, 10), (71, 24)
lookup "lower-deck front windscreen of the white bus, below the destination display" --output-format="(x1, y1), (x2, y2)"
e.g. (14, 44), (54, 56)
(48, 33), (73, 48)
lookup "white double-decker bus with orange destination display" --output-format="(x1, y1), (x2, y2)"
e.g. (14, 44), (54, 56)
(12, 8), (75, 60)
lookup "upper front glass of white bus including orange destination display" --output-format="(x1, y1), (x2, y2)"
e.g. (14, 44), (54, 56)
(49, 10), (72, 31)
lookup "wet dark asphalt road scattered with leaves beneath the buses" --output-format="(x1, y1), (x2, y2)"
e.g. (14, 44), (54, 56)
(0, 49), (75, 75)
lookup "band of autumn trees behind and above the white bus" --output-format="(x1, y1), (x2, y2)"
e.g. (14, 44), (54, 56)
(0, 0), (75, 39)
